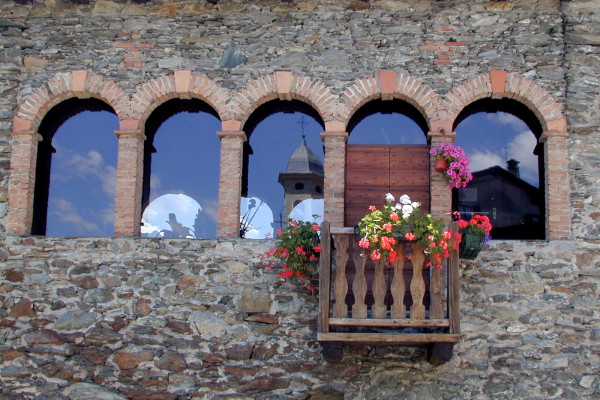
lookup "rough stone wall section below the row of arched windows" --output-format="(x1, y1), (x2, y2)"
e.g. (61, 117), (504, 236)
(0, 237), (600, 399)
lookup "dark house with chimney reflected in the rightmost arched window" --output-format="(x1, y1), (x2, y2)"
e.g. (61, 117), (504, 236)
(456, 159), (544, 239)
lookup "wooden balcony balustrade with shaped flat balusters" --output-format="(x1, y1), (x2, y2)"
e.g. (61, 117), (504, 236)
(318, 222), (460, 361)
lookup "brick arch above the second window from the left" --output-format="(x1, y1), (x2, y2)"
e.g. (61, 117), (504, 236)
(127, 70), (231, 132)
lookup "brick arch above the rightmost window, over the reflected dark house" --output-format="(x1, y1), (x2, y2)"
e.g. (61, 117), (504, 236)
(436, 70), (567, 132)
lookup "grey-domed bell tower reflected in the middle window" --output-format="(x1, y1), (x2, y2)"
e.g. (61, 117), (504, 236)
(279, 135), (324, 219)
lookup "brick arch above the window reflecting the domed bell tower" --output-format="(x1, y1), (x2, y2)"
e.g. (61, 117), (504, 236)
(229, 71), (339, 129)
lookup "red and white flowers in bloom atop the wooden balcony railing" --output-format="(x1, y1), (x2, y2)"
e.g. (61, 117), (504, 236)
(358, 193), (461, 269)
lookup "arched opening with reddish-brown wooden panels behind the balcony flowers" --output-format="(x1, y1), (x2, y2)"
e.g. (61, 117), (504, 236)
(345, 99), (430, 226)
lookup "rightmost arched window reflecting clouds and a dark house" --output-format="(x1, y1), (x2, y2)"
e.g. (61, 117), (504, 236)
(453, 99), (545, 239)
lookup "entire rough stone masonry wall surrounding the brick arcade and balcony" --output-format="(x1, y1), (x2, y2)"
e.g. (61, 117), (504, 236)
(0, 0), (600, 400)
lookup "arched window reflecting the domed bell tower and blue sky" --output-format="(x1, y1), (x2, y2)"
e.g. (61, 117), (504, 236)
(240, 100), (324, 238)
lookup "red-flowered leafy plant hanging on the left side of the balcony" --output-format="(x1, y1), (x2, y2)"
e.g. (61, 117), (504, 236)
(261, 215), (321, 290)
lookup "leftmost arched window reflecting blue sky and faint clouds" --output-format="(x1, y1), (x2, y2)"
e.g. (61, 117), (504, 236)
(31, 98), (119, 236)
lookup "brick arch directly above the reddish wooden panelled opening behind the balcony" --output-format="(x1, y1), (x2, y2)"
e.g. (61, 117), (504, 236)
(340, 71), (439, 129)
